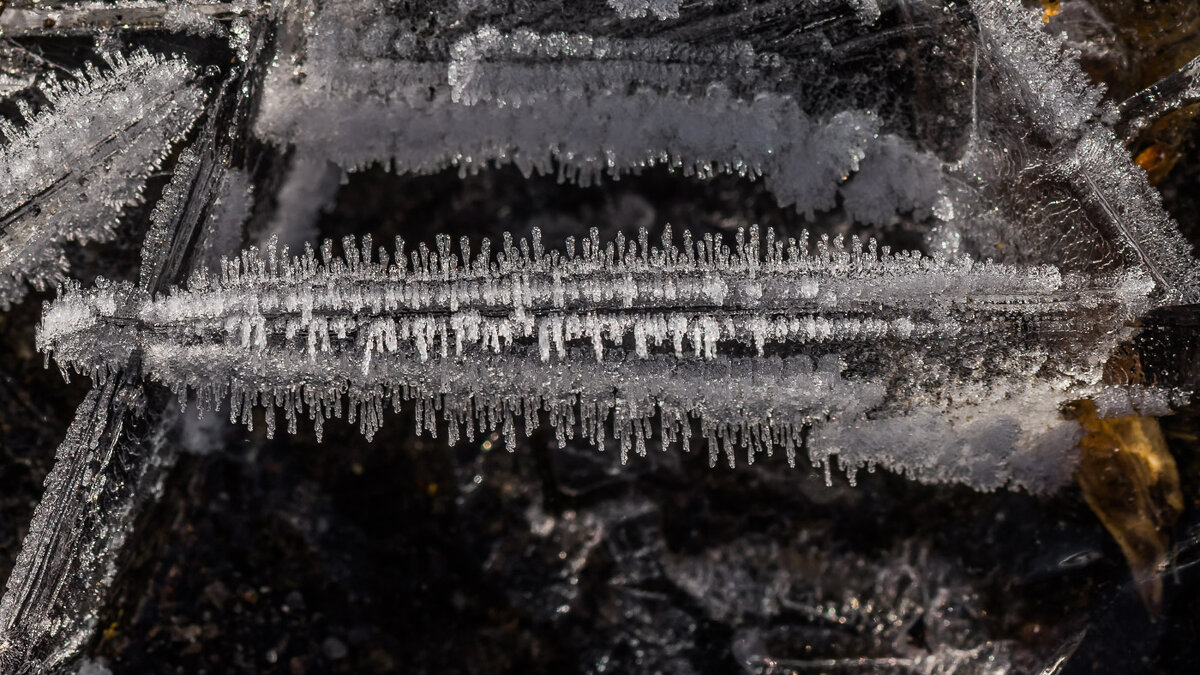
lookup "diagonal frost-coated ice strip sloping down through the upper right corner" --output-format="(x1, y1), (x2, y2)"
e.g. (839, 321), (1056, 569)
(971, 0), (1200, 299)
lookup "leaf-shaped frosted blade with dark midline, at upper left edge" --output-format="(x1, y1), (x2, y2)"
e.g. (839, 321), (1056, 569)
(0, 52), (203, 307)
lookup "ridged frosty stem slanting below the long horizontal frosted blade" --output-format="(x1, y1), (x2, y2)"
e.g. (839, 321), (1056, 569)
(0, 377), (172, 673)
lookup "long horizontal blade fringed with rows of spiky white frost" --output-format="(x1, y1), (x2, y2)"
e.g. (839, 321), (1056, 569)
(37, 229), (1148, 490)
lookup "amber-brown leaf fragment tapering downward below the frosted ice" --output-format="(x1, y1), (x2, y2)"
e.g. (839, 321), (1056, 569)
(1073, 400), (1183, 615)
